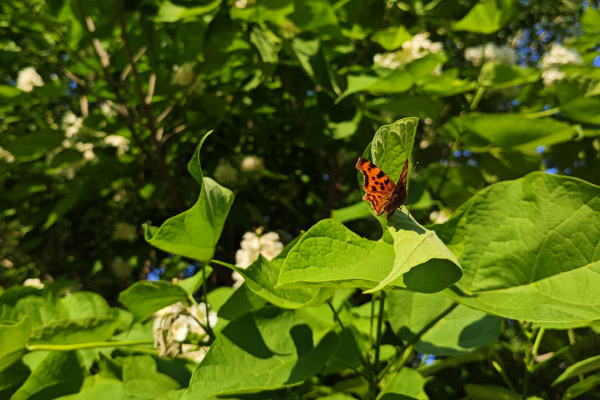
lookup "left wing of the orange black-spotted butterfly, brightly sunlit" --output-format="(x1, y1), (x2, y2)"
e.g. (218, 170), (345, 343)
(356, 157), (394, 215)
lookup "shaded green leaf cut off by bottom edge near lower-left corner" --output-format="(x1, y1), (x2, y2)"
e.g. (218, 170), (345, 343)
(11, 351), (84, 400)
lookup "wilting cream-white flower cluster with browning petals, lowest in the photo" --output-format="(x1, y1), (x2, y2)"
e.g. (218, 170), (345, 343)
(153, 302), (217, 362)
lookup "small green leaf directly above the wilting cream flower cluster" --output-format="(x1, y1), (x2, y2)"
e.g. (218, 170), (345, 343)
(119, 281), (188, 321)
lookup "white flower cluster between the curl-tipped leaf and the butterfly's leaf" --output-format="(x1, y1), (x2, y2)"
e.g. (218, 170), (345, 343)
(232, 230), (283, 288)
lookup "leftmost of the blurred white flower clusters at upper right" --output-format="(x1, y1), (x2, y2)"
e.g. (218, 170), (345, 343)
(373, 32), (444, 69)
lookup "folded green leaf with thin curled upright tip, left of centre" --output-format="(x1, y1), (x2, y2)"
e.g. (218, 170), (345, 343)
(146, 132), (234, 262)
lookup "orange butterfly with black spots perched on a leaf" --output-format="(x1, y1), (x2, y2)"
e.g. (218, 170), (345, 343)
(356, 157), (408, 219)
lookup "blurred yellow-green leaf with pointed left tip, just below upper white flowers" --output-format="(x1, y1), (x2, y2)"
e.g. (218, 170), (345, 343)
(335, 70), (413, 104)
